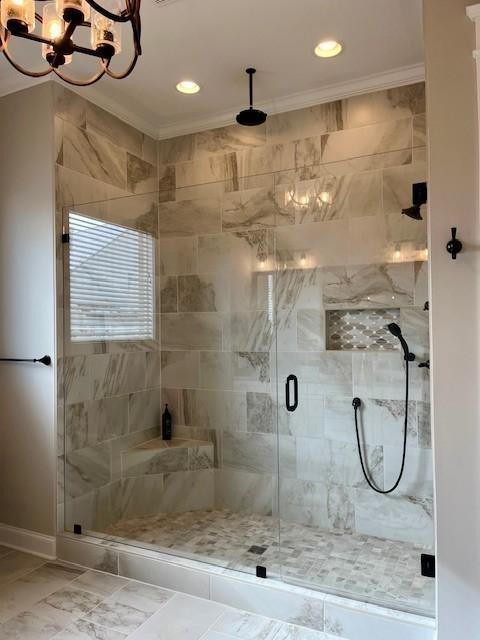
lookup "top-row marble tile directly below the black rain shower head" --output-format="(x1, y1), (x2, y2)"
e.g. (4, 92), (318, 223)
(195, 124), (266, 159)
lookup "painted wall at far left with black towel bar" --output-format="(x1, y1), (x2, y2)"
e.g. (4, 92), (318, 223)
(0, 83), (56, 535)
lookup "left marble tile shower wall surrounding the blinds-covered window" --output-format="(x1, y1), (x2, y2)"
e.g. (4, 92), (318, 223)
(52, 84), (167, 529)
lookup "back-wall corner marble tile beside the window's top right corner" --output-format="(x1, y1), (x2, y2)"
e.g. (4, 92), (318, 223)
(158, 198), (221, 238)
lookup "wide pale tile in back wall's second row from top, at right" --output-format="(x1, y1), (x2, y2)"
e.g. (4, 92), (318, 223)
(322, 118), (412, 162)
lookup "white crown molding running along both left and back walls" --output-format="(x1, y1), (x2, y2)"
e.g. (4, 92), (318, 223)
(0, 62), (422, 140)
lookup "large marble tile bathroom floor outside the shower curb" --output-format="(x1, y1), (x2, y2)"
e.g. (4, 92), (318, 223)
(0, 547), (341, 640)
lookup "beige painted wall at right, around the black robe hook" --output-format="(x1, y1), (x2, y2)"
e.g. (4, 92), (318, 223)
(424, 0), (480, 640)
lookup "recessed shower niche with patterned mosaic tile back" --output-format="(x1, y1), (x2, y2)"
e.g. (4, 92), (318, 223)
(325, 309), (400, 351)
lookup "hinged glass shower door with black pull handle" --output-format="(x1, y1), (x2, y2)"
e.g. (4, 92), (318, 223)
(275, 149), (434, 615)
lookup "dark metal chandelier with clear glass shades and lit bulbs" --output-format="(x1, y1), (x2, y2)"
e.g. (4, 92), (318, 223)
(0, 0), (142, 86)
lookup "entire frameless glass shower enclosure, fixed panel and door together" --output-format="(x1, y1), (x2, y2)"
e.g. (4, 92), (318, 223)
(62, 148), (434, 615)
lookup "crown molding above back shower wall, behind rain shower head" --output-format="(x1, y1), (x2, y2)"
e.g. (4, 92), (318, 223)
(156, 62), (424, 140)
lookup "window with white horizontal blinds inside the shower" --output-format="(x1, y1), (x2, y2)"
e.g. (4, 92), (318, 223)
(69, 212), (155, 342)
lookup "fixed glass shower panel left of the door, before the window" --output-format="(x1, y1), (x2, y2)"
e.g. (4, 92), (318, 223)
(63, 175), (280, 576)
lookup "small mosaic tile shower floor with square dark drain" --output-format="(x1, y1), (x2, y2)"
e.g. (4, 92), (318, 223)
(102, 511), (435, 615)
